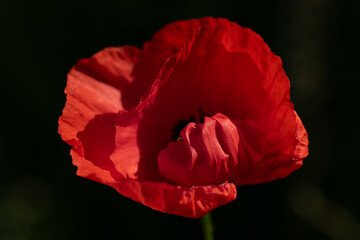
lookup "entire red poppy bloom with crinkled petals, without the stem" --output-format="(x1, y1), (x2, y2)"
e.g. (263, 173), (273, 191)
(59, 18), (308, 217)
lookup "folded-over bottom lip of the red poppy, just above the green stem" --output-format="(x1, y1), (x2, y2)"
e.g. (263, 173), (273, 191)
(114, 179), (236, 218)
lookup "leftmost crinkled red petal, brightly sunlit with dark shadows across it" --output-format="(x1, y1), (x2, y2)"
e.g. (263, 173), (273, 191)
(59, 47), (138, 185)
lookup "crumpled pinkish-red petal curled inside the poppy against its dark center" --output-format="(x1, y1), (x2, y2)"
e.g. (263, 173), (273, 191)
(158, 111), (241, 186)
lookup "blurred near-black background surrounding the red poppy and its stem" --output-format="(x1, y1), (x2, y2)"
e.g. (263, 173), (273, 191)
(0, 0), (360, 240)
